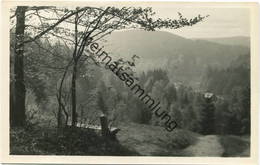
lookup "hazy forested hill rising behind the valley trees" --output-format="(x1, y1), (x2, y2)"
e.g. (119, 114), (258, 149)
(105, 30), (250, 87)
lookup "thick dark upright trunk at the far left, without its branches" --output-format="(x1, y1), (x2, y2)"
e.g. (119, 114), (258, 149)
(10, 6), (26, 127)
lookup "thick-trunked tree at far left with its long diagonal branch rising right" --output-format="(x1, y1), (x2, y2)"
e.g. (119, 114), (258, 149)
(10, 6), (91, 126)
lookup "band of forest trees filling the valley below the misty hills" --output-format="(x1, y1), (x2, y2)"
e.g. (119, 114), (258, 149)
(11, 36), (250, 137)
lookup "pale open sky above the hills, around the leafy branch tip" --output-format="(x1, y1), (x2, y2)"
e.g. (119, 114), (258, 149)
(153, 5), (250, 38)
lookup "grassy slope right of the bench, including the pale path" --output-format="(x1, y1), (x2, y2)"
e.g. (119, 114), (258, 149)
(118, 123), (250, 157)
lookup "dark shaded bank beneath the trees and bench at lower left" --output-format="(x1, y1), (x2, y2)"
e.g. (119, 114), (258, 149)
(10, 127), (138, 156)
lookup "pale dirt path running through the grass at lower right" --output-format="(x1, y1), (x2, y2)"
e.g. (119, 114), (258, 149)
(184, 135), (224, 157)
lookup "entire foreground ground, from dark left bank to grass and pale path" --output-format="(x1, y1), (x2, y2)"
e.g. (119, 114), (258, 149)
(10, 123), (250, 157)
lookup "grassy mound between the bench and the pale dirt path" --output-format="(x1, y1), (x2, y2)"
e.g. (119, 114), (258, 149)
(118, 123), (198, 156)
